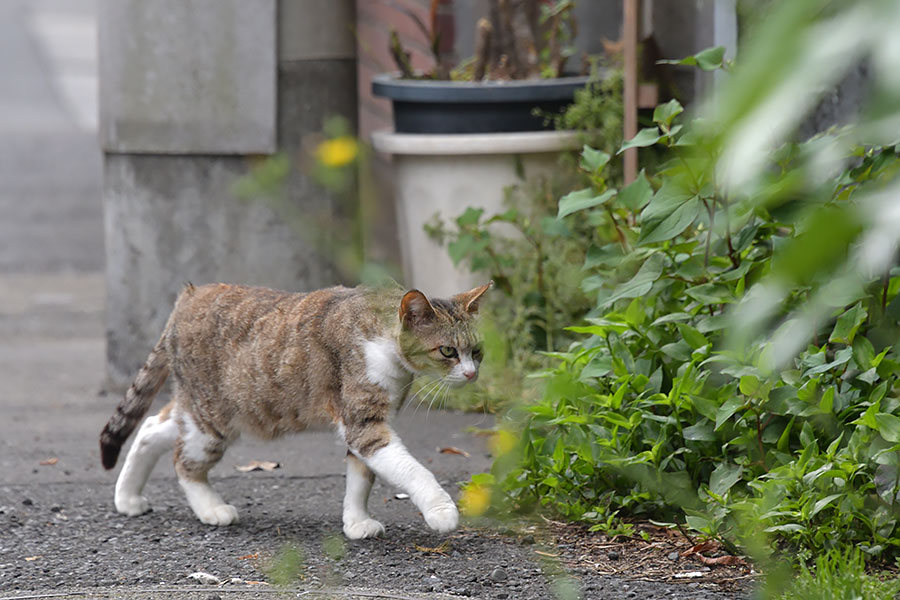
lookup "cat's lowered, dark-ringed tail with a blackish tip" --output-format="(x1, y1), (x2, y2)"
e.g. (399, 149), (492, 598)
(100, 327), (169, 469)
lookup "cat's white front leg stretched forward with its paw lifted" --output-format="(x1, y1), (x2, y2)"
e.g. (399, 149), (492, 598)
(351, 432), (459, 533)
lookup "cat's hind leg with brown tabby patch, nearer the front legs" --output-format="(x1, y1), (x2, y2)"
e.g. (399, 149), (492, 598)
(175, 412), (238, 525)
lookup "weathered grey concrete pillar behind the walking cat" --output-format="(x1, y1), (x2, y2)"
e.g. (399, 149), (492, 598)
(99, 0), (356, 388)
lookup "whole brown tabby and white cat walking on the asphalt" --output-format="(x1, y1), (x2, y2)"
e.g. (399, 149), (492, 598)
(100, 282), (493, 539)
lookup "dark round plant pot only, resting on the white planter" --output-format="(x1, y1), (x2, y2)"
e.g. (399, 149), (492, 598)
(372, 74), (590, 133)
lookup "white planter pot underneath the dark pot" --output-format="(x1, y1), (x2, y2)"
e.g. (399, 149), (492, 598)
(372, 131), (579, 297)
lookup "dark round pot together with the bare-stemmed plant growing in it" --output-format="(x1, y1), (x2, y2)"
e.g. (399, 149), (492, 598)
(372, 0), (588, 133)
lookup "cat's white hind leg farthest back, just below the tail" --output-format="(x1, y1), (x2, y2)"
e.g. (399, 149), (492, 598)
(115, 403), (178, 517)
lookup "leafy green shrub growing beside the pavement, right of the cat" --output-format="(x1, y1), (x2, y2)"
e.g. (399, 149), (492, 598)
(494, 111), (900, 556)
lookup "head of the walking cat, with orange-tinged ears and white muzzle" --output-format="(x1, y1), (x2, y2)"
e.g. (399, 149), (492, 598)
(400, 281), (494, 386)
